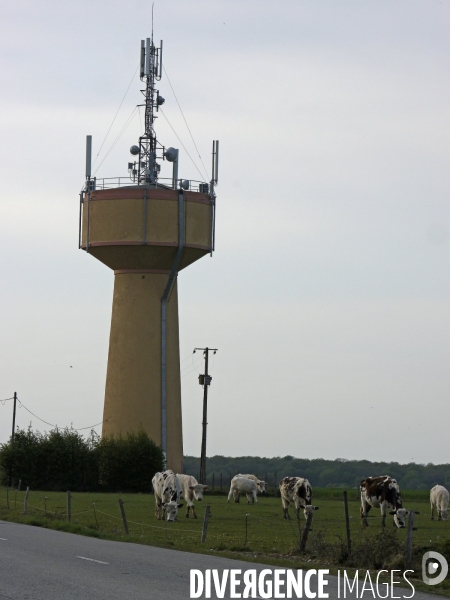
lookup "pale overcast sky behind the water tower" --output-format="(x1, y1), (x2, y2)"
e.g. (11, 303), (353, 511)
(0, 0), (450, 463)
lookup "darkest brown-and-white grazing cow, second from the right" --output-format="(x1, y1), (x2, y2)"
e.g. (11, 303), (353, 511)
(359, 475), (409, 529)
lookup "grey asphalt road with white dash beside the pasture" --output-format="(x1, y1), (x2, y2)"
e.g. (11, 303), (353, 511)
(0, 521), (442, 600)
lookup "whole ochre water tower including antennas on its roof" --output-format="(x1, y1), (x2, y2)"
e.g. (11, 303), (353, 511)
(79, 35), (219, 472)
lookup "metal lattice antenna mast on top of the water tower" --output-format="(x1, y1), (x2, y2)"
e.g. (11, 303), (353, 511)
(137, 34), (164, 185)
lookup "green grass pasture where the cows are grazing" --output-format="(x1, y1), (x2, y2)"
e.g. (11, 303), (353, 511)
(0, 488), (450, 596)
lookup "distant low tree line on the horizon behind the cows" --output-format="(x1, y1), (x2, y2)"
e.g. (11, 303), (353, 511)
(184, 456), (450, 490)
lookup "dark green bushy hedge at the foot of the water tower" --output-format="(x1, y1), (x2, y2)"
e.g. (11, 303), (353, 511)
(0, 427), (163, 492)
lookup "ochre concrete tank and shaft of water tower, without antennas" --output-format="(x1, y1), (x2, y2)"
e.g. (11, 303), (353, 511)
(81, 186), (213, 472)
